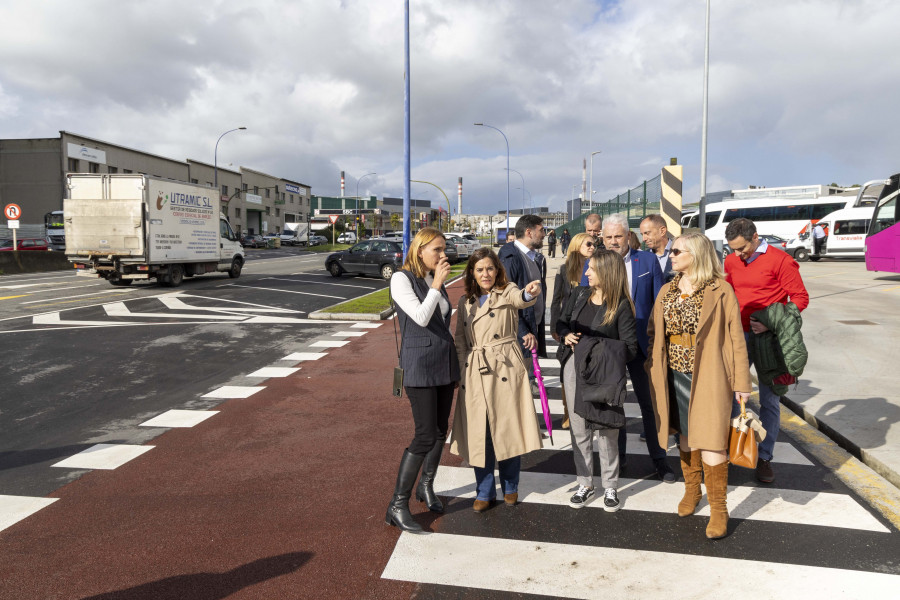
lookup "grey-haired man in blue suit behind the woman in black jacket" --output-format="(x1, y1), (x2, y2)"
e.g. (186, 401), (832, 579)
(603, 214), (675, 483)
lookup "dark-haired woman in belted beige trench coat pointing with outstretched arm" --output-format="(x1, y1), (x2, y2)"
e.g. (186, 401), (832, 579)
(450, 248), (541, 512)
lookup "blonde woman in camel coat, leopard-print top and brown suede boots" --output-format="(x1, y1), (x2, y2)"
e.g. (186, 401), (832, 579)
(645, 233), (752, 539)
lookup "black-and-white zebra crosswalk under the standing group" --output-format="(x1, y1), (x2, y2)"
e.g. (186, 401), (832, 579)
(382, 340), (900, 600)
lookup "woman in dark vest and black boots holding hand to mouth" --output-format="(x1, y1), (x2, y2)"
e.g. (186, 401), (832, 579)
(385, 227), (459, 533)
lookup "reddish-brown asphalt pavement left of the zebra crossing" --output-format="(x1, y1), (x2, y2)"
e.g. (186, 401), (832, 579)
(0, 282), (472, 600)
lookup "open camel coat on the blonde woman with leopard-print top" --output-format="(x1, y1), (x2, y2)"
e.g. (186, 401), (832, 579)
(644, 279), (753, 451)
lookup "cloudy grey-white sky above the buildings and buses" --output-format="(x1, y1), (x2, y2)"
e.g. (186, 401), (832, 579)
(0, 0), (900, 213)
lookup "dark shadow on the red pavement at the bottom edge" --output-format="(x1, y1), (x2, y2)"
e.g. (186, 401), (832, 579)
(82, 552), (313, 600)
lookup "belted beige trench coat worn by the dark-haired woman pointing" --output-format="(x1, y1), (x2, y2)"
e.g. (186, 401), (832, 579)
(450, 283), (541, 467)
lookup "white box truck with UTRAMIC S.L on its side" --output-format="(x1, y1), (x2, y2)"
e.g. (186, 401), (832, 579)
(63, 174), (244, 287)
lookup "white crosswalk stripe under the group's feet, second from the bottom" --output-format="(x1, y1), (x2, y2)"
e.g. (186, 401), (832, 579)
(434, 466), (889, 532)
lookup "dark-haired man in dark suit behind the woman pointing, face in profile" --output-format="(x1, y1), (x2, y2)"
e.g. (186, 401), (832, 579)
(498, 215), (547, 382)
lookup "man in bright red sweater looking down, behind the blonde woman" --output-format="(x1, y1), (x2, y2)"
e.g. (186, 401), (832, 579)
(725, 219), (809, 483)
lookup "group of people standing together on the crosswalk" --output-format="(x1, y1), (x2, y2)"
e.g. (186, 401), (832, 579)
(386, 209), (809, 539)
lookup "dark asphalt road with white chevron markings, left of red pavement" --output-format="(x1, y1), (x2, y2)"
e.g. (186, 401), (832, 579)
(0, 248), (386, 496)
